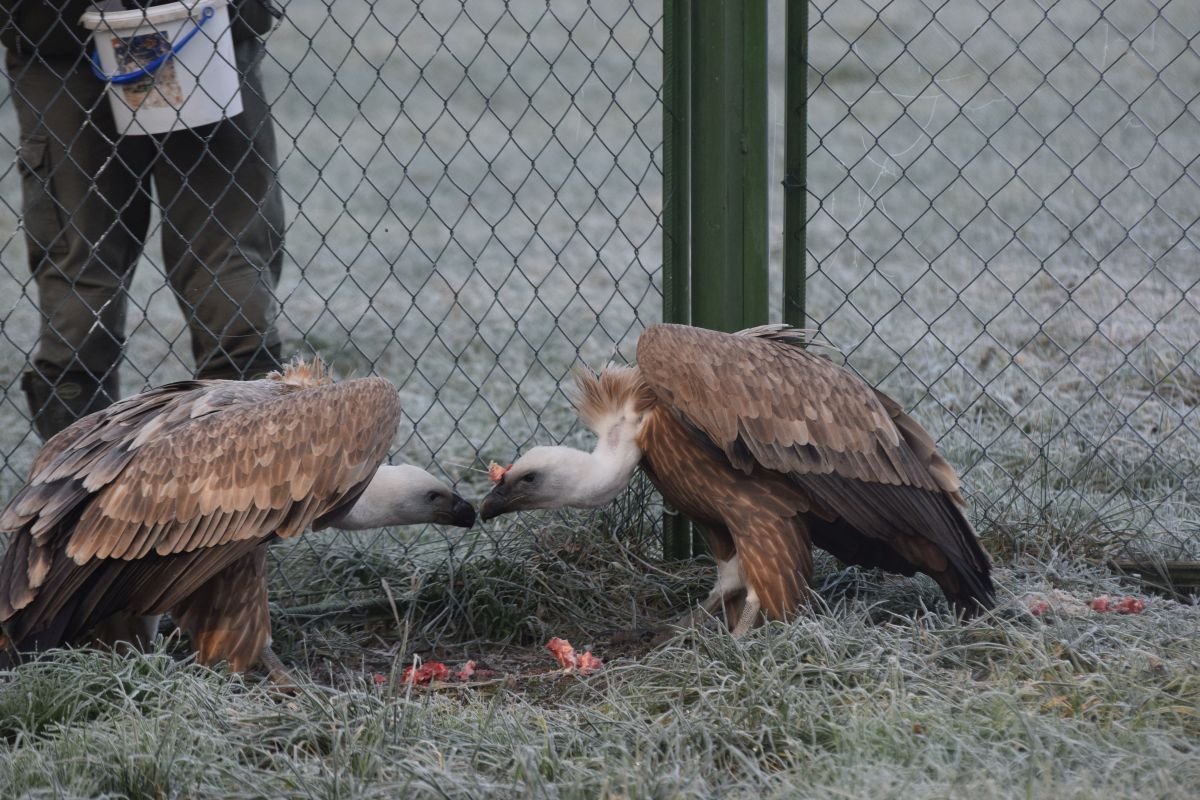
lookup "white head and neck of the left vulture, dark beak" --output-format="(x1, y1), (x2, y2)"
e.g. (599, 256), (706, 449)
(331, 464), (475, 530)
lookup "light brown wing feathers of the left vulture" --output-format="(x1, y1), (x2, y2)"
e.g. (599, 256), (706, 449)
(66, 378), (400, 563)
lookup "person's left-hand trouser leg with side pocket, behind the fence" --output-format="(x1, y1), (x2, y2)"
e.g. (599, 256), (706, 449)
(6, 53), (150, 439)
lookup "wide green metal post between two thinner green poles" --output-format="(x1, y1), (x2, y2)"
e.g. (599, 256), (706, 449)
(690, 0), (768, 331)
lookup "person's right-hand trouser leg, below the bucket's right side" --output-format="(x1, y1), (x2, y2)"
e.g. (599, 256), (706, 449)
(155, 40), (283, 378)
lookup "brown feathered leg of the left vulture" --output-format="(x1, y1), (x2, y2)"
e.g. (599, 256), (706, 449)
(170, 545), (282, 682)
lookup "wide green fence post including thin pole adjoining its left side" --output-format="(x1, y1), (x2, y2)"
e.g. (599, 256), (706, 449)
(662, 0), (769, 558)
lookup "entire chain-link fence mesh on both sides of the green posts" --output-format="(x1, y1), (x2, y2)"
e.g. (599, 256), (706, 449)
(0, 0), (1200, 618)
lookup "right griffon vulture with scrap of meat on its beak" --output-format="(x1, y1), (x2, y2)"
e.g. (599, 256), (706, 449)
(480, 325), (994, 636)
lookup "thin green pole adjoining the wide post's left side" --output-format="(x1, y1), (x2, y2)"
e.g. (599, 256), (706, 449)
(662, 0), (691, 559)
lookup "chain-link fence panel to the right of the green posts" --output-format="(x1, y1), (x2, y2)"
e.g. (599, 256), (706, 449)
(808, 0), (1200, 557)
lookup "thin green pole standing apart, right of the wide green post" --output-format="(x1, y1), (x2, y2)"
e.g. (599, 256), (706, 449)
(784, 0), (809, 327)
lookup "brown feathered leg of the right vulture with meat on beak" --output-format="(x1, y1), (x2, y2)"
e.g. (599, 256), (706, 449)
(730, 512), (812, 636)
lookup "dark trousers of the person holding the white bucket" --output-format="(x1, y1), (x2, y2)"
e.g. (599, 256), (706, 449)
(6, 38), (283, 438)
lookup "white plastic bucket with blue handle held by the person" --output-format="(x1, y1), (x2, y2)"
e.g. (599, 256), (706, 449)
(79, 0), (241, 134)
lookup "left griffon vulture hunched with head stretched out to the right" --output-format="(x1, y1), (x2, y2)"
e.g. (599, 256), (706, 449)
(0, 361), (475, 681)
